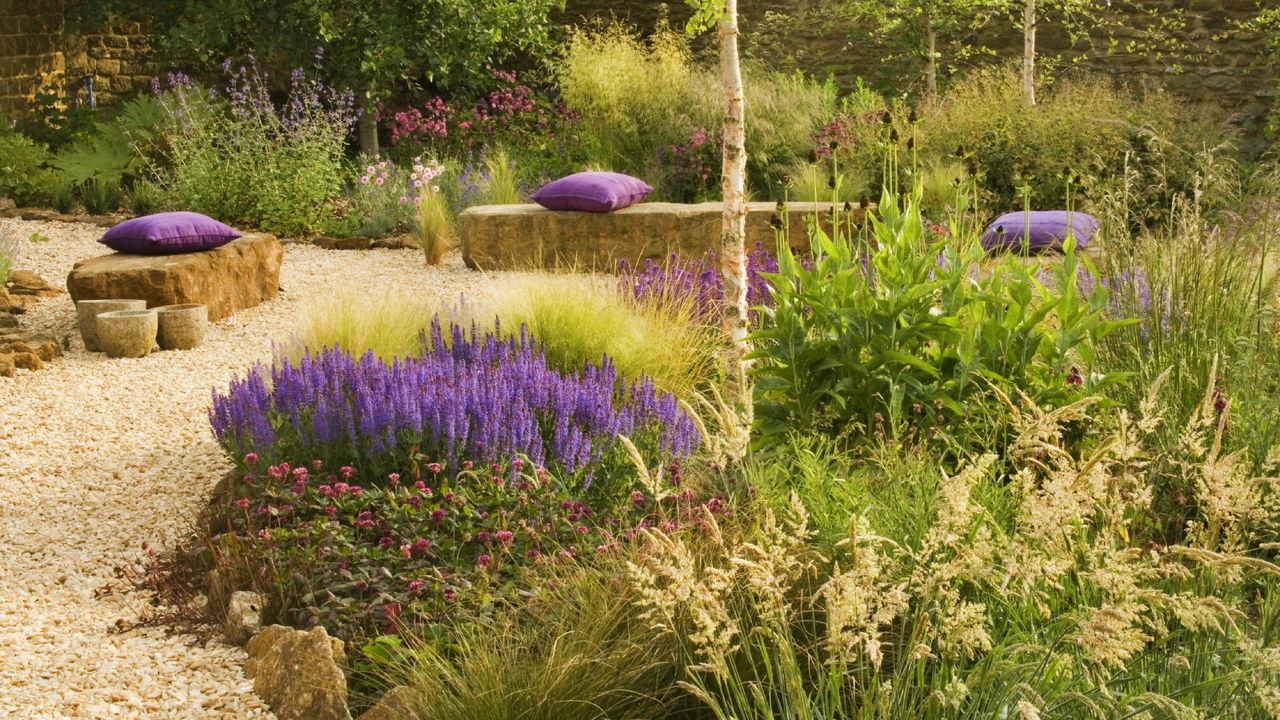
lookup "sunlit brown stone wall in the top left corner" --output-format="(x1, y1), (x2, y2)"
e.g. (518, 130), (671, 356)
(0, 0), (151, 114)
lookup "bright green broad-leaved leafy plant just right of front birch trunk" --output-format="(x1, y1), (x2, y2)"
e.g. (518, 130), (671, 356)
(751, 180), (1115, 443)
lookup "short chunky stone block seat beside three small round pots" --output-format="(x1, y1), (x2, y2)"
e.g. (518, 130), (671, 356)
(67, 234), (284, 322)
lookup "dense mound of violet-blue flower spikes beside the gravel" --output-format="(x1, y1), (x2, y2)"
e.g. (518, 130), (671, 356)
(210, 320), (699, 487)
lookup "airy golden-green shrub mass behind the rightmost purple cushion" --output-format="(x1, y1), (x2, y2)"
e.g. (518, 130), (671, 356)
(921, 68), (1236, 224)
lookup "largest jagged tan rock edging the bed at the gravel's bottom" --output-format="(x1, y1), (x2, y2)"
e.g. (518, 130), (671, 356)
(244, 625), (351, 720)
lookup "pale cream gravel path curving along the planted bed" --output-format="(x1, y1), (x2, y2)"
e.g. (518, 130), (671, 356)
(0, 219), (492, 719)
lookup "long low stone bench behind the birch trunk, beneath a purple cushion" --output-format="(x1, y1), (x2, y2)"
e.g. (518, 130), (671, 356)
(458, 202), (863, 272)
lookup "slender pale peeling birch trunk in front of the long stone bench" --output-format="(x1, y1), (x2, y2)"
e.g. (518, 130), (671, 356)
(719, 0), (751, 421)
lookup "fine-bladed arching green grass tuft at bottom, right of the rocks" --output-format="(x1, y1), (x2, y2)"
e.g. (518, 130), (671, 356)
(383, 562), (682, 720)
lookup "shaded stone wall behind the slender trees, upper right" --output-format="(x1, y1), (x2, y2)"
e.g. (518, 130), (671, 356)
(564, 0), (1280, 132)
